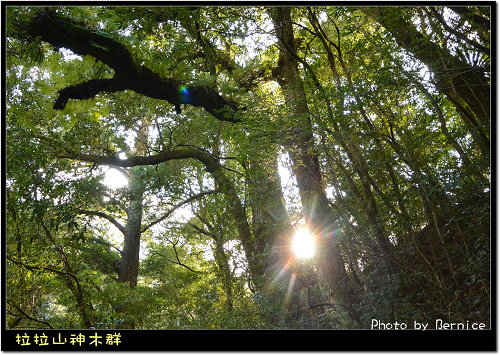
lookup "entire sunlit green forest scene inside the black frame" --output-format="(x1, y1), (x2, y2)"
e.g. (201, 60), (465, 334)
(4, 3), (491, 329)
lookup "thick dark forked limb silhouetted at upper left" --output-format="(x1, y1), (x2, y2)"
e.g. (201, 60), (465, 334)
(28, 8), (240, 122)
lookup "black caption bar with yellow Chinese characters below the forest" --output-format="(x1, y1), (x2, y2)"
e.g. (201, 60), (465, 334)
(2, 329), (496, 351)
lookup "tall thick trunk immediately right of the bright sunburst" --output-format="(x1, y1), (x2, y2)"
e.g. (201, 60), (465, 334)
(271, 7), (345, 300)
